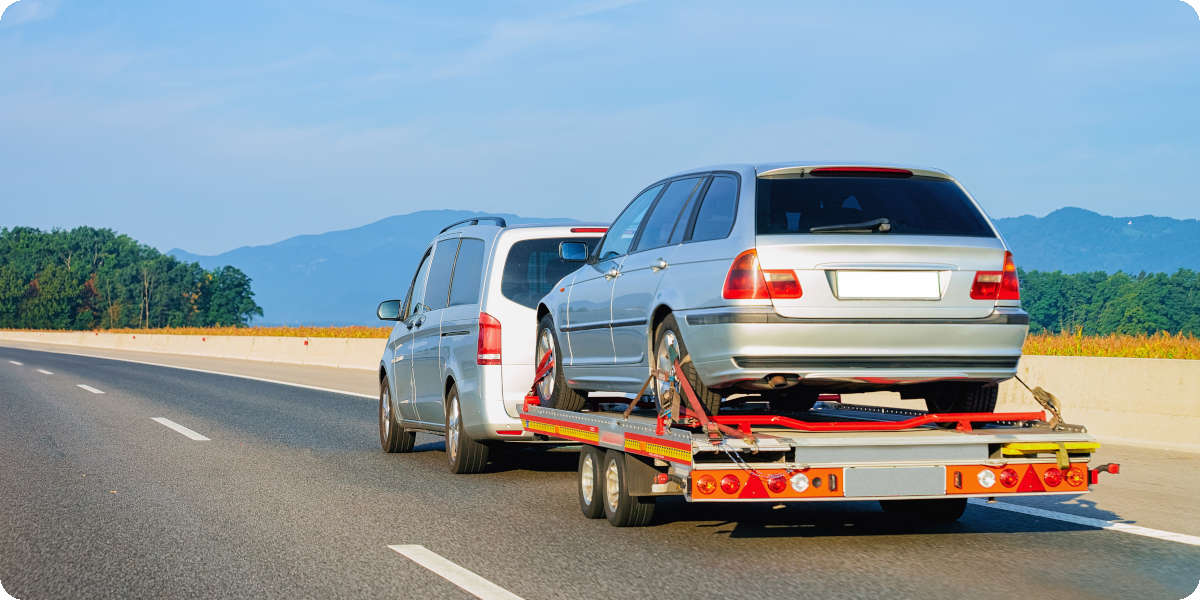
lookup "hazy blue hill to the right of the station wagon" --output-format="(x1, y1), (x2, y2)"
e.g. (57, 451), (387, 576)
(996, 206), (1200, 274)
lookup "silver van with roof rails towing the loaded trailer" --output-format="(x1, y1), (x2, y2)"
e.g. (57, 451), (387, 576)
(377, 217), (605, 473)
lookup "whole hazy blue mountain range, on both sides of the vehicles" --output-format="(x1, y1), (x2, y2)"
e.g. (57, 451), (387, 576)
(168, 208), (1200, 325)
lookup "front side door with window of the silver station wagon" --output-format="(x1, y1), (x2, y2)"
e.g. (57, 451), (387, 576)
(559, 184), (662, 367)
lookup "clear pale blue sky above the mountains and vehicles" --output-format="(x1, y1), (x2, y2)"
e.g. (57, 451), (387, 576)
(0, 0), (1200, 253)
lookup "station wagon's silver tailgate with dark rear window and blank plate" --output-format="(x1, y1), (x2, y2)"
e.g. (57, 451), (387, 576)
(755, 167), (1004, 319)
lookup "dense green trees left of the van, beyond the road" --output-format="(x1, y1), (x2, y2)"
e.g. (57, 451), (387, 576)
(0, 227), (263, 329)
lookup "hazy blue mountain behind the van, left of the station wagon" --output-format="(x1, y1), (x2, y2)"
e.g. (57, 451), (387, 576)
(168, 210), (570, 325)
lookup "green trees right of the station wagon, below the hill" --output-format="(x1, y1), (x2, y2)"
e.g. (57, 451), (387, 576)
(1019, 269), (1200, 335)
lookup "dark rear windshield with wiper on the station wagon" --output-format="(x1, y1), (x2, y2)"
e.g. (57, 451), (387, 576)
(756, 175), (995, 238)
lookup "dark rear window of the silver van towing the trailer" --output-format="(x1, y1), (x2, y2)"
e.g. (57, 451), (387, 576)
(500, 238), (600, 308)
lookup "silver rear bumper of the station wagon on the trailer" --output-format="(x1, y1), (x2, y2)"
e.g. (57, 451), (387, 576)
(679, 307), (1028, 389)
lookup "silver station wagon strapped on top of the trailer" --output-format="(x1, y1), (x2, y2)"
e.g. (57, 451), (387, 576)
(536, 163), (1028, 413)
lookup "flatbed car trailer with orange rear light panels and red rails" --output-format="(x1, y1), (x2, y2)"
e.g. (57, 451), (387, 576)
(521, 355), (1120, 527)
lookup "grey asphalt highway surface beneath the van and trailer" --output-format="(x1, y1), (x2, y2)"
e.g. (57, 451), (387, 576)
(0, 347), (1200, 600)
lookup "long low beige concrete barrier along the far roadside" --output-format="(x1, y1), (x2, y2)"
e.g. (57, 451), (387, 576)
(0, 331), (1200, 452)
